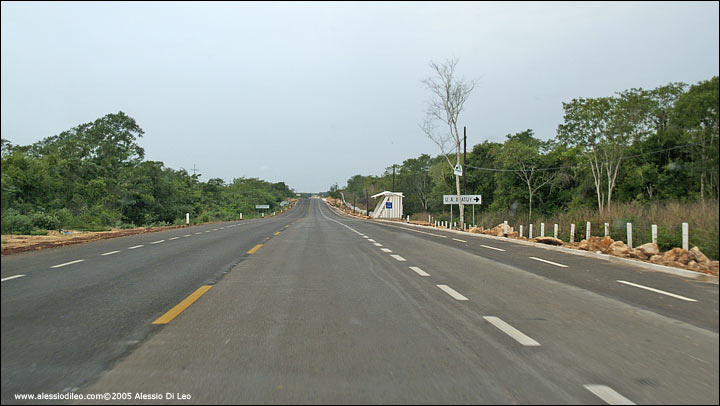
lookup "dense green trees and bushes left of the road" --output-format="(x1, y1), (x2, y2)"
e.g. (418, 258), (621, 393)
(2, 112), (294, 234)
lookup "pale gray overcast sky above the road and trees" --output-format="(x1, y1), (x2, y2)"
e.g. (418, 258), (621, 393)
(0, 2), (719, 192)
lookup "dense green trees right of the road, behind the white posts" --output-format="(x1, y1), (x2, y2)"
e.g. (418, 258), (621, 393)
(329, 77), (719, 258)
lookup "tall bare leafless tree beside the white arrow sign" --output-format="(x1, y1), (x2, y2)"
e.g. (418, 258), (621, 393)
(421, 59), (476, 228)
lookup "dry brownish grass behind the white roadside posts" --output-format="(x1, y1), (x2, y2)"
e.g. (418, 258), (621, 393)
(464, 201), (720, 260)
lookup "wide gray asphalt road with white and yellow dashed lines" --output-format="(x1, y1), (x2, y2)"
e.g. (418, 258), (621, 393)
(2, 199), (719, 404)
